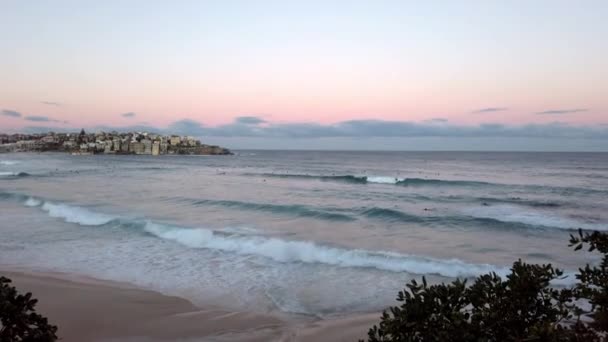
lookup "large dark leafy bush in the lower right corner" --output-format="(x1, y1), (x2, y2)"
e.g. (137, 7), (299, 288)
(368, 231), (608, 342)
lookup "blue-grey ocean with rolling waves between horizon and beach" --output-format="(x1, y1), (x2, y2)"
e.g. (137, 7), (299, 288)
(0, 151), (608, 318)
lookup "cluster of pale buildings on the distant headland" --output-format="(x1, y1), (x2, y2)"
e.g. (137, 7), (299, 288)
(0, 130), (232, 155)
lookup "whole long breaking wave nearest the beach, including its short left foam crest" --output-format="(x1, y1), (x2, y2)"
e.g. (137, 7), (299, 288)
(10, 197), (508, 277)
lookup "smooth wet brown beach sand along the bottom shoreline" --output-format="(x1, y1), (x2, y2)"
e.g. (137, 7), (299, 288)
(0, 270), (379, 342)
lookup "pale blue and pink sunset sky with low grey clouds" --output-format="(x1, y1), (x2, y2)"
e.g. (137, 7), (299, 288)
(0, 0), (608, 151)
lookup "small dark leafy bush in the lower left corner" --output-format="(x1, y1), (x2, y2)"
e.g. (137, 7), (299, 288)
(0, 276), (57, 342)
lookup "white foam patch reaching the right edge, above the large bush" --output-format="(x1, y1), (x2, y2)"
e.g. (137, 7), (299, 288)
(467, 205), (607, 230)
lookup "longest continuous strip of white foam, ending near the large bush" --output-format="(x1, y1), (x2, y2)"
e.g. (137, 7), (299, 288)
(144, 222), (507, 277)
